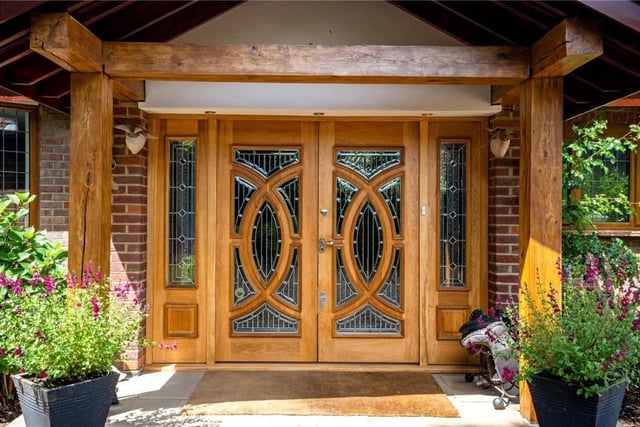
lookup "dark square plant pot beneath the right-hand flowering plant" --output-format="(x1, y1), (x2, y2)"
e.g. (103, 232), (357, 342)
(529, 375), (626, 427)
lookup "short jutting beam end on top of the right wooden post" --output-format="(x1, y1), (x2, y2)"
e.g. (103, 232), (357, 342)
(531, 19), (603, 77)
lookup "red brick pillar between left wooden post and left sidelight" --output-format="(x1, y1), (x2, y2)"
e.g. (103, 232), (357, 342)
(111, 103), (147, 370)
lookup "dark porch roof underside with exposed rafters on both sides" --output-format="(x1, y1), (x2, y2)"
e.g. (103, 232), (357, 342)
(0, 0), (640, 118)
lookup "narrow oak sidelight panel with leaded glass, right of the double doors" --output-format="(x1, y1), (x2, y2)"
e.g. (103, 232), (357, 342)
(423, 121), (488, 365)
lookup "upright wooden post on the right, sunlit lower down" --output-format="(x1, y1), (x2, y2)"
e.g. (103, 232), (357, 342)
(519, 77), (562, 420)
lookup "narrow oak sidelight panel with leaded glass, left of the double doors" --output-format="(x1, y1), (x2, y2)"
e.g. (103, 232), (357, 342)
(148, 119), (209, 363)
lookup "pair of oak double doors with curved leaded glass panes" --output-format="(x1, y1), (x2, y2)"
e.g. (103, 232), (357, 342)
(214, 120), (420, 363)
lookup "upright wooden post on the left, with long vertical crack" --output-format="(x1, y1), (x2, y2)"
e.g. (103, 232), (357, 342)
(69, 73), (113, 275)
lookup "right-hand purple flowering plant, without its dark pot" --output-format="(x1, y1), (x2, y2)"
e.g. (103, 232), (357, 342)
(506, 256), (640, 397)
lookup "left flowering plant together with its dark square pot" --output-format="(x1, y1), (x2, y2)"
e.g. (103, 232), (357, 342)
(0, 265), (146, 426)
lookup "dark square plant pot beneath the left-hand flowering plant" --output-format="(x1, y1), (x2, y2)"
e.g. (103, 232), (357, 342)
(12, 372), (118, 427)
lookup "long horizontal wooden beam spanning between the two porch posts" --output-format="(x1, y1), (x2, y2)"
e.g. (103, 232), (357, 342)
(103, 42), (530, 85)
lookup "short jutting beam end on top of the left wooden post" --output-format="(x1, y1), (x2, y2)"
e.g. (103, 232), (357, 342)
(30, 13), (102, 73)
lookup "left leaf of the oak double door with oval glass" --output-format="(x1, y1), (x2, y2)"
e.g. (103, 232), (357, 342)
(216, 120), (317, 361)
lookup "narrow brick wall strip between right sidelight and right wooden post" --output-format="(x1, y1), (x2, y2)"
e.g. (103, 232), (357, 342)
(488, 111), (520, 308)
